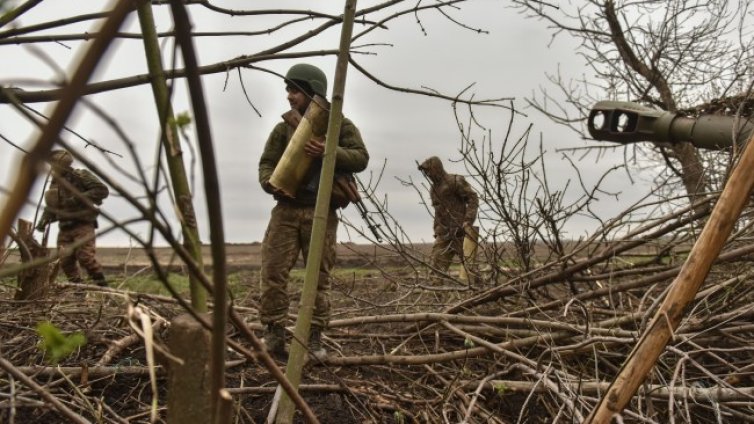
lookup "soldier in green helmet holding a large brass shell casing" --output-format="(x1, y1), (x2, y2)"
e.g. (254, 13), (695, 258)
(259, 63), (369, 358)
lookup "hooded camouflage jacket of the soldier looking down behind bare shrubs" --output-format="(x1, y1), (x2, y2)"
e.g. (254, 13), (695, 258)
(422, 156), (479, 237)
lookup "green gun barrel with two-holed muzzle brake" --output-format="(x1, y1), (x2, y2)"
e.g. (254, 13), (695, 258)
(587, 101), (754, 150)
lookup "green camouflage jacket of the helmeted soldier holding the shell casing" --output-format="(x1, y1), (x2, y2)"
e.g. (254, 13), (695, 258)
(259, 118), (369, 206)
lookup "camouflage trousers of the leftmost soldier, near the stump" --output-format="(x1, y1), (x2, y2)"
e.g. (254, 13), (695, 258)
(58, 223), (102, 281)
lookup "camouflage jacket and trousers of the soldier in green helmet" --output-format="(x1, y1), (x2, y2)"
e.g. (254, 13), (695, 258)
(259, 114), (369, 328)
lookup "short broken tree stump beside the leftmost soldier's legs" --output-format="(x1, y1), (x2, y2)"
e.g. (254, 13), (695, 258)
(15, 219), (51, 300)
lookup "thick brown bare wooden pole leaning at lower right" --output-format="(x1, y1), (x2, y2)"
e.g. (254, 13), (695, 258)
(584, 132), (754, 424)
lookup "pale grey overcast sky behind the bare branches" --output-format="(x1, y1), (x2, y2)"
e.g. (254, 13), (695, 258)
(0, 0), (648, 246)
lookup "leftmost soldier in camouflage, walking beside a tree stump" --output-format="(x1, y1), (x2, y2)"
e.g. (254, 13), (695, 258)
(36, 150), (110, 286)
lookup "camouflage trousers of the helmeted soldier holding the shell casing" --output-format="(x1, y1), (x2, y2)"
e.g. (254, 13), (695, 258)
(259, 203), (338, 328)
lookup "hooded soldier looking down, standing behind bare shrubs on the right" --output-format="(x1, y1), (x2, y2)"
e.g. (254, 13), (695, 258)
(419, 156), (479, 280)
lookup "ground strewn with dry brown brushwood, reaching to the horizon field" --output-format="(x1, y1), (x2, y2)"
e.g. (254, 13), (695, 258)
(0, 207), (754, 423)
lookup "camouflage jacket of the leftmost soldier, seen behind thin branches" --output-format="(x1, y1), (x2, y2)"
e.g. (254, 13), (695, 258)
(42, 169), (110, 229)
